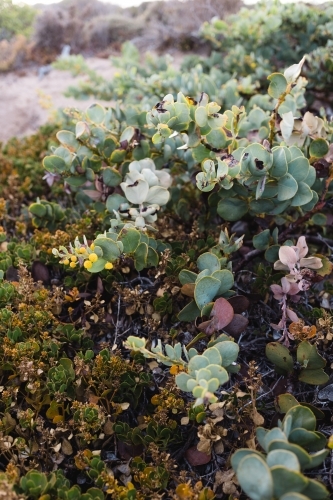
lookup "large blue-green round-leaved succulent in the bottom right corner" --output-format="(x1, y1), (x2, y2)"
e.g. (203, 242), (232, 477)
(231, 405), (329, 500)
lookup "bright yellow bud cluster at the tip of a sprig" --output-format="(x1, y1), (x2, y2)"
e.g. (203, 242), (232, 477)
(52, 236), (113, 270)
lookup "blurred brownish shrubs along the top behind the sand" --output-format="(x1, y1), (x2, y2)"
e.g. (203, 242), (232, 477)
(0, 0), (242, 71)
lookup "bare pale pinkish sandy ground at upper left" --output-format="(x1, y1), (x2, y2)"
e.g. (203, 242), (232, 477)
(0, 57), (115, 142)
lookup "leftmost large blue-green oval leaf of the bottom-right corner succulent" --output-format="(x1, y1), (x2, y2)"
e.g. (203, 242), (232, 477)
(237, 453), (273, 500)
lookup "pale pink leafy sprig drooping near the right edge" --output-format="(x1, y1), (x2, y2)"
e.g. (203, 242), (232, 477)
(271, 236), (323, 346)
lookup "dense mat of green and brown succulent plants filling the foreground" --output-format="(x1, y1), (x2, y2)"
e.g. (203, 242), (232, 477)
(0, 3), (333, 500)
